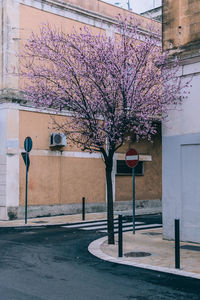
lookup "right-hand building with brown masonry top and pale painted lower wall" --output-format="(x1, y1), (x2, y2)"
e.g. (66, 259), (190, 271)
(162, 0), (200, 242)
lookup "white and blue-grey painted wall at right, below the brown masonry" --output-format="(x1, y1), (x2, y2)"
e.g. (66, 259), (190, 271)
(162, 57), (200, 242)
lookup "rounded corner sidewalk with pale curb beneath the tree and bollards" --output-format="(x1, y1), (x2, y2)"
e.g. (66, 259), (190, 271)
(88, 228), (200, 279)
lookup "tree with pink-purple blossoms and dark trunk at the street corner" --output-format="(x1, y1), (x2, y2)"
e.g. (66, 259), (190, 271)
(20, 19), (186, 244)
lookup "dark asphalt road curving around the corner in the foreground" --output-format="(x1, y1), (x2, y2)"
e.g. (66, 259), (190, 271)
(0, 216), (200, 300)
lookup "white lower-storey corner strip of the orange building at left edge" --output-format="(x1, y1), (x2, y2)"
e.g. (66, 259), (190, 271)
(0, 104), (19, 220)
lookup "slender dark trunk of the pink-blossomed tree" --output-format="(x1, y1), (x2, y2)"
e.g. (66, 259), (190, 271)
(106, 158), (115, 244)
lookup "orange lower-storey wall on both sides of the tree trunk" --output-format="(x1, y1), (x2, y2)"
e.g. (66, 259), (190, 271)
(19, 111), (161, 205)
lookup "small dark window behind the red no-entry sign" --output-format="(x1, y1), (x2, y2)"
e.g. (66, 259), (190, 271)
(117, 160), (144, 176)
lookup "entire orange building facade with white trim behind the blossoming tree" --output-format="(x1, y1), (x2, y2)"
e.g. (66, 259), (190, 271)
(0, 0), (161, 220)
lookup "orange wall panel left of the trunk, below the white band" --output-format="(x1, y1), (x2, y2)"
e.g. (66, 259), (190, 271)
(20, 155), (105, 205)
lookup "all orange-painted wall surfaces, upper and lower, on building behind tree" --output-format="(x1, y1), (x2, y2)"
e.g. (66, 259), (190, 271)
(19, 0), (161, 205)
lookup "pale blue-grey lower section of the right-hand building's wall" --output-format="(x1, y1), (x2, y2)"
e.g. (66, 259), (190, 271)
(162, 133), (200, 243)
